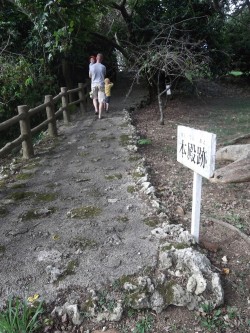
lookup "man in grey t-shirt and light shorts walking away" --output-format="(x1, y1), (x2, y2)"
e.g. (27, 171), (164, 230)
(89, 53), (106, 119)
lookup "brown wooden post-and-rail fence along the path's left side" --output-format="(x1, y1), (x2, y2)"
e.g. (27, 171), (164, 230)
(0, 83), (88, 159)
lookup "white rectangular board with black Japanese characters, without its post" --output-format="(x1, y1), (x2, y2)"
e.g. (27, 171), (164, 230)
(177, 126), (216, 178)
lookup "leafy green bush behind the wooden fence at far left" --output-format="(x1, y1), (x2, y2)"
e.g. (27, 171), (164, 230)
(0, 55), (59, 141)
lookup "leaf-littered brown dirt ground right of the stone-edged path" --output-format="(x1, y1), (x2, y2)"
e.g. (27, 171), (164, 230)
(130, 77), (250, 333)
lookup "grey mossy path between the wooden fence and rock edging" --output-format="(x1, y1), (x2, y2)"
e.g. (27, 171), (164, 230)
(0, 72), (157, 302)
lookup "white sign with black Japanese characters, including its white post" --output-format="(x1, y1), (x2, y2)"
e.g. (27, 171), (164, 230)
(177, 126), (216, 243)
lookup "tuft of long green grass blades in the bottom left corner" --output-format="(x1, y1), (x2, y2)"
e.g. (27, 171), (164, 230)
(0, 298), (44, 333)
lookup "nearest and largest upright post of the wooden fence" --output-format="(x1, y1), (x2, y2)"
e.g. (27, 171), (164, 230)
(17, 105), (34, 159)
